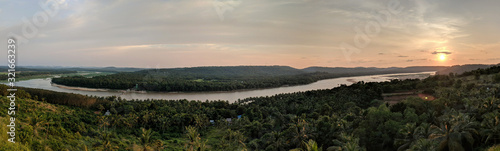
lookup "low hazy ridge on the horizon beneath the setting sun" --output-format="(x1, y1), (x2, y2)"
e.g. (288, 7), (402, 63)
(302, 66), (448, 74)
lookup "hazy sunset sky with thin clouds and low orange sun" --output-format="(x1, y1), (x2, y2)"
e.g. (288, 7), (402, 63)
(0, 0), (500, 68)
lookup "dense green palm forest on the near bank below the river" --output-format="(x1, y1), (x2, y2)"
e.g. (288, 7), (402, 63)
(0, 67), (500, 151)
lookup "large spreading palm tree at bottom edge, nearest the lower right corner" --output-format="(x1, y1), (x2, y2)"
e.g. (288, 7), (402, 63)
(429, 110), (478, 151)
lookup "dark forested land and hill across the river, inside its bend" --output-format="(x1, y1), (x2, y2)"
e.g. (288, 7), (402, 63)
(52, 66), (443, 92)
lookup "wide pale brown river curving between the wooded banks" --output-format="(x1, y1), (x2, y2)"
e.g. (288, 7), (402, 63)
(10, 72), (435, 102)
